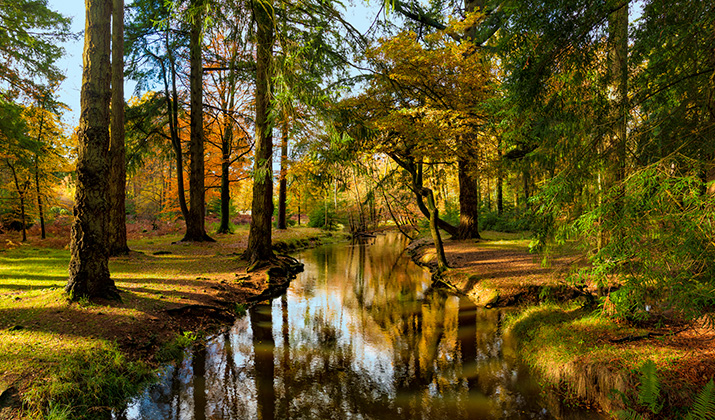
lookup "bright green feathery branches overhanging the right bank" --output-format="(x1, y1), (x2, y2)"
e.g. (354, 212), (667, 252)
(573, 156), (715, 321)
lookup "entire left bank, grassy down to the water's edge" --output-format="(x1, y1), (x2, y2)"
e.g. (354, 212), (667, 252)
(0, 228), (343, 419)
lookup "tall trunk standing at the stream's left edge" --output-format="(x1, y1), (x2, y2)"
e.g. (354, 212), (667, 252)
(244, 0), (274, 264)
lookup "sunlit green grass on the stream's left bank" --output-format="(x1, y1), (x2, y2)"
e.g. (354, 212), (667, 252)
(0, 228), (339, 419)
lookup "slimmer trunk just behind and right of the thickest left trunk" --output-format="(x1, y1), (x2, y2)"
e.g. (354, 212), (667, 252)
(107, 0), (129, 256)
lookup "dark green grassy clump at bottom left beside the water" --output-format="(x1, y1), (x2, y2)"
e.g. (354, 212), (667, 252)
(24, 347), (155, 419)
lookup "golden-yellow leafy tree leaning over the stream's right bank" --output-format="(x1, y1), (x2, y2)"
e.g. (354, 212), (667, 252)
(343, 27), (490, 237)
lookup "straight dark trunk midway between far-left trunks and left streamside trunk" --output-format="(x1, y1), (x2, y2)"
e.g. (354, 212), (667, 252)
(182, 0), (213, 242)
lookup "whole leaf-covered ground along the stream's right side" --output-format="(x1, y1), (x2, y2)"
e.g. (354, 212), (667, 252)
(411, 232), (715, 418)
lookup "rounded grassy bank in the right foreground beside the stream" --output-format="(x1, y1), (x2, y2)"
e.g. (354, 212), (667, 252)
(505, 304), (715, 419)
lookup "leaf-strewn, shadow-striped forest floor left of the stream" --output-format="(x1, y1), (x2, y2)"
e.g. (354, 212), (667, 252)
(0, 221), (344, 419)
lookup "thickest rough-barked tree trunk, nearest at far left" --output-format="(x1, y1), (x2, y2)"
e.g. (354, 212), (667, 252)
(65, 0), (119, 300)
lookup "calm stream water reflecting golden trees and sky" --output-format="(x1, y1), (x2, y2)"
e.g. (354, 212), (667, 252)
(115, 234), (601, 420)
